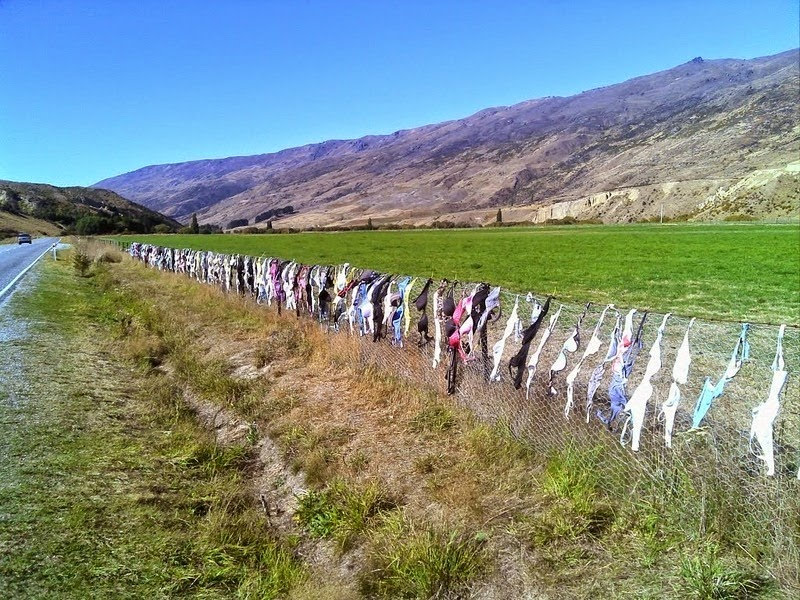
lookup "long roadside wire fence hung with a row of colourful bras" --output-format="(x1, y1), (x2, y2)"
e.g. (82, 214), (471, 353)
(108, 241), (800, 585)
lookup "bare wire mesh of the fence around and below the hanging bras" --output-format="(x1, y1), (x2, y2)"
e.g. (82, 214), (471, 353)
(111, 242), (800, 583)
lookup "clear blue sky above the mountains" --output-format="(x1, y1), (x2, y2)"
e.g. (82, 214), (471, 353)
(0, 0), (800, 185)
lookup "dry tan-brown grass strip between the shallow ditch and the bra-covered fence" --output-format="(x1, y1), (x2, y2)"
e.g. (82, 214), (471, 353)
(90, 248), (544, 584)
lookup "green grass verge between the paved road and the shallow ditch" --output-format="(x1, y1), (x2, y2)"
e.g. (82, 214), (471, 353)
(0, 251), (307, 598)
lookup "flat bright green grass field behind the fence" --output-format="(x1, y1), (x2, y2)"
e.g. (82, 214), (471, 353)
(118, 223), (800, 325)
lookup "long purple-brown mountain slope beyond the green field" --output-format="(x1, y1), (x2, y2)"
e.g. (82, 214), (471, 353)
(94, 49), (800, 227)
